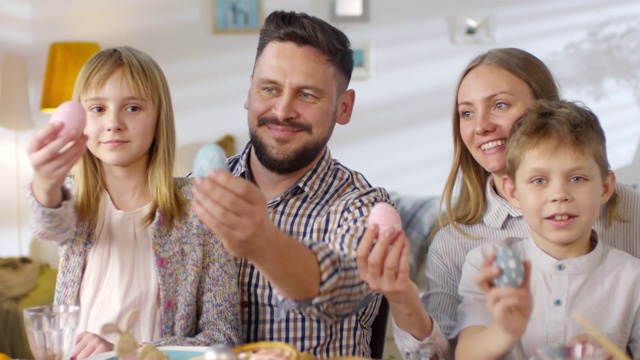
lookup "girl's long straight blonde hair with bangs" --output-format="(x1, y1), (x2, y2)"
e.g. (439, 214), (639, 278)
(73, 46), (187, 227)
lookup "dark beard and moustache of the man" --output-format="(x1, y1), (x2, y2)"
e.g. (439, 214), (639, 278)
(249, 117), (331, 175)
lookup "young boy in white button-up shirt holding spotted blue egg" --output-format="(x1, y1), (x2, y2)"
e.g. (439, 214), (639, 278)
(456, 101), (640, 359)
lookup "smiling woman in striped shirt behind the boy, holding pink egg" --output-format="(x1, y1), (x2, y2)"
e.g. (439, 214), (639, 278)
(358, 48), (640, 358)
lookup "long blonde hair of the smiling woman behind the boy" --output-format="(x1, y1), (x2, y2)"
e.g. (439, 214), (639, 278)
(429, 48), (622, 240)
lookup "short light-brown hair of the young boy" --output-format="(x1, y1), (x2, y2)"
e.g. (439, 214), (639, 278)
(505, 100), (620, 223)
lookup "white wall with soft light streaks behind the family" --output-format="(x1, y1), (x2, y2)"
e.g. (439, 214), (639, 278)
(0, 0), (640, 264)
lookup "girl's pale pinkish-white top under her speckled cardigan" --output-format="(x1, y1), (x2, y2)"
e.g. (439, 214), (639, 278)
(78, 192), (161, 343)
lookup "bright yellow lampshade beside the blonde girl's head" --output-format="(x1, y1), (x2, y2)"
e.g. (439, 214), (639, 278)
(40, 42), (100, 113)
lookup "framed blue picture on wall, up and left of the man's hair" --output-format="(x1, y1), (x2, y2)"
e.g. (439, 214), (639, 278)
(212, 0), (263, 34)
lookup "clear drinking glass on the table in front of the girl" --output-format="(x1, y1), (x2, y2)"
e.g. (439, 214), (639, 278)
(23, 305), (80, 360)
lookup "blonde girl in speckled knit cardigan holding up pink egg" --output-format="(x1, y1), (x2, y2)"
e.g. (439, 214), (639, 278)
(27, 46), (240, 359)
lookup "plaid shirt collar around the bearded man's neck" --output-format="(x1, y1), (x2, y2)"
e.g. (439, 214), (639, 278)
(233, 141), (334, 199)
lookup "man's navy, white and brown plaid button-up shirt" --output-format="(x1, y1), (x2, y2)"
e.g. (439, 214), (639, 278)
(228, 144), (390, 359)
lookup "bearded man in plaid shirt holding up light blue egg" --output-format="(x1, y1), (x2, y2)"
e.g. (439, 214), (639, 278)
(192, 11), (390, 359)
